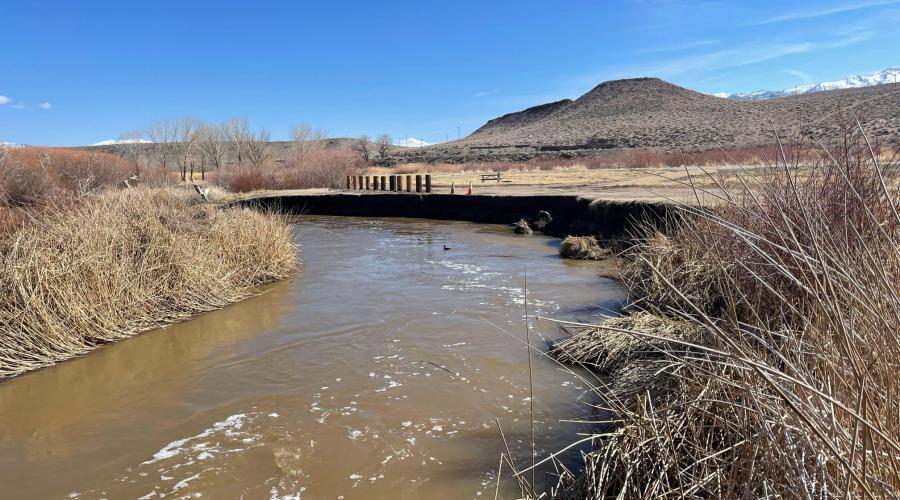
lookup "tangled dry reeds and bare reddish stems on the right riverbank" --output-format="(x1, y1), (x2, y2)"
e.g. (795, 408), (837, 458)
(557, 134), (900, 498)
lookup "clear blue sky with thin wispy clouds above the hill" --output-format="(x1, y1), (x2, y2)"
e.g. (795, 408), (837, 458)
(0, 0), (900, 145)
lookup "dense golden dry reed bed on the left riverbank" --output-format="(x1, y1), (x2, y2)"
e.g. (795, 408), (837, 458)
(0, 189), (298, 378)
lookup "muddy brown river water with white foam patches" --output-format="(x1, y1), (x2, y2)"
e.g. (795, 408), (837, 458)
(0, 217), (624, 499)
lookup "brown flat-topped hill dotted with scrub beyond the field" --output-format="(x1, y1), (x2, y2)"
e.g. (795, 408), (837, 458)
(400, 78), (900, 161)
